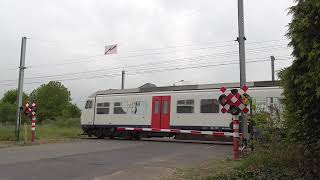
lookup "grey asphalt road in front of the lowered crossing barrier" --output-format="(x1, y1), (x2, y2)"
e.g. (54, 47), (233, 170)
(0, 139), (232, 180)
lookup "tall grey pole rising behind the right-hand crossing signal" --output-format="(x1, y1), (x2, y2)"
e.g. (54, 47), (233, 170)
(237, 0), (249, 139)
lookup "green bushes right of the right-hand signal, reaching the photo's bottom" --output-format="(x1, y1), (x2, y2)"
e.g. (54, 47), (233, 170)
(208, 112), (313, 180)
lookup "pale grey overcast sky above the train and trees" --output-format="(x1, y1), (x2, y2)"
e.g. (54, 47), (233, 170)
(0, 0), (293, 107)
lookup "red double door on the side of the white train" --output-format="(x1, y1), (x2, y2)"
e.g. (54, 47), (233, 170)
(151, 96), (171, 129)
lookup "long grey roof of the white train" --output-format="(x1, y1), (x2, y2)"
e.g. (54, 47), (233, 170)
(90, 81), (279, 97)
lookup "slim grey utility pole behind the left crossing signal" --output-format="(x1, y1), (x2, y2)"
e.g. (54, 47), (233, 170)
(16, 37), (27, 141)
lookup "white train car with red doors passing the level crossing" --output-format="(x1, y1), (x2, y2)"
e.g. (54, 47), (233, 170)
(81, 82), (282, 139)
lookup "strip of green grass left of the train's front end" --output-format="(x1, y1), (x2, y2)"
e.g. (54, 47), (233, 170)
(0, 118), (82, 144)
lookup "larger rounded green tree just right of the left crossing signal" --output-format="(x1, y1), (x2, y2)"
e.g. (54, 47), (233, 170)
(30, 81), (71, 121)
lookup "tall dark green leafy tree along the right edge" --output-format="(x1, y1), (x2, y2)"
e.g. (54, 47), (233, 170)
(280, 0), (320, 176)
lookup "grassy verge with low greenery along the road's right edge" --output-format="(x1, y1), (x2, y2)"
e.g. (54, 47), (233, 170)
(164, 143), (304, 180)
